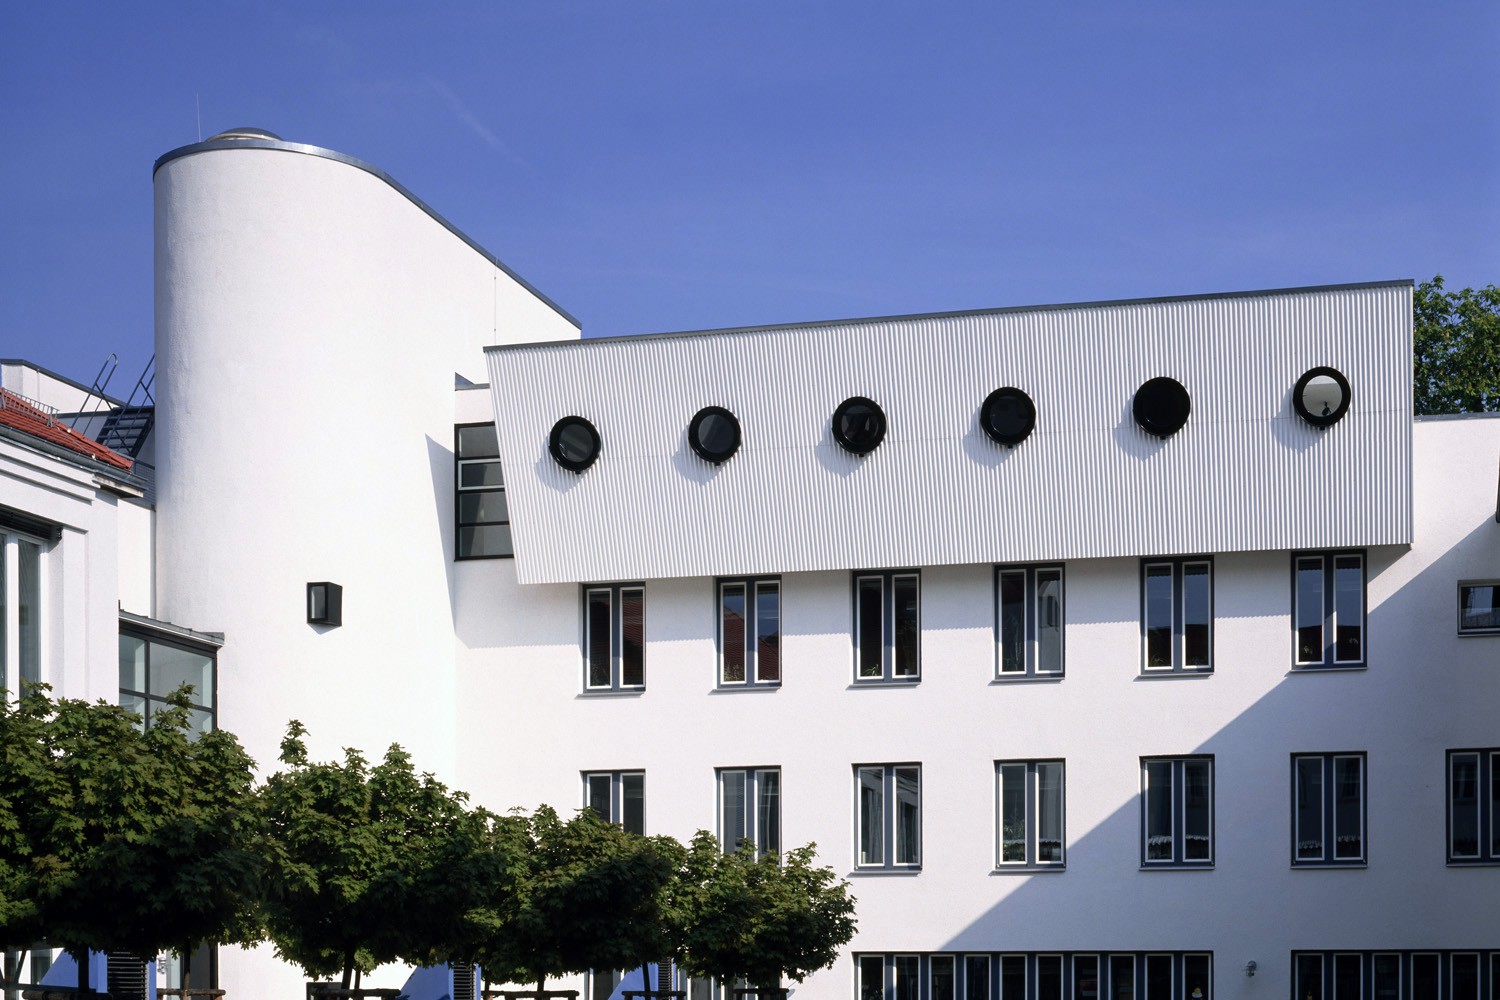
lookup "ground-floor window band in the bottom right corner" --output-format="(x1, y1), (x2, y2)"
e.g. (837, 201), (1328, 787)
(1292, 951), (1500, 1000)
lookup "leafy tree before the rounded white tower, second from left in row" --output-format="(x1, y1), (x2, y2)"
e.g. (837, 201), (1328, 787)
(261, 721), (488, 988)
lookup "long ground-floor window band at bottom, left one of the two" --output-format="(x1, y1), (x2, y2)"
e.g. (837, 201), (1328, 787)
(855, 952), (1206, 1000)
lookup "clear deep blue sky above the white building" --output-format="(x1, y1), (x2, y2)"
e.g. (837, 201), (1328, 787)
(0, 0), (1500, 388)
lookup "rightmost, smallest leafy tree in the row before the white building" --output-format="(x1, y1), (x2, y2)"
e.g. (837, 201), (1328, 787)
(680, 831), (855, 988)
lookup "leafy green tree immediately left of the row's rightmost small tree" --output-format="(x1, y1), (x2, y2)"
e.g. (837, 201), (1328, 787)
(474, 805), (683, 993)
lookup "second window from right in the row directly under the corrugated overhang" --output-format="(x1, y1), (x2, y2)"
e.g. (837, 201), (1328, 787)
(1140, 556), (1214, 673)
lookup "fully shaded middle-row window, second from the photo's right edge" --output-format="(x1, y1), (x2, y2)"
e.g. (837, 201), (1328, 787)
(1292, 753), (1365, 865)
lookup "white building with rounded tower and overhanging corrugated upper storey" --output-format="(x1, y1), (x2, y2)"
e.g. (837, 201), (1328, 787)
(0, 130), (1500, 1000)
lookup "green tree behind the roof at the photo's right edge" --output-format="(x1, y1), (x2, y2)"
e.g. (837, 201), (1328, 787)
(1413, 274), (1500, 414)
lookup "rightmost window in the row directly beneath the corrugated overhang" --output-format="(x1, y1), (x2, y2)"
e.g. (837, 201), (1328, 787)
(1292, 552), (1365, 669)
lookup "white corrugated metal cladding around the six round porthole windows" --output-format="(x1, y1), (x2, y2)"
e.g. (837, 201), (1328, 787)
(488, 283), (1412, 583)
